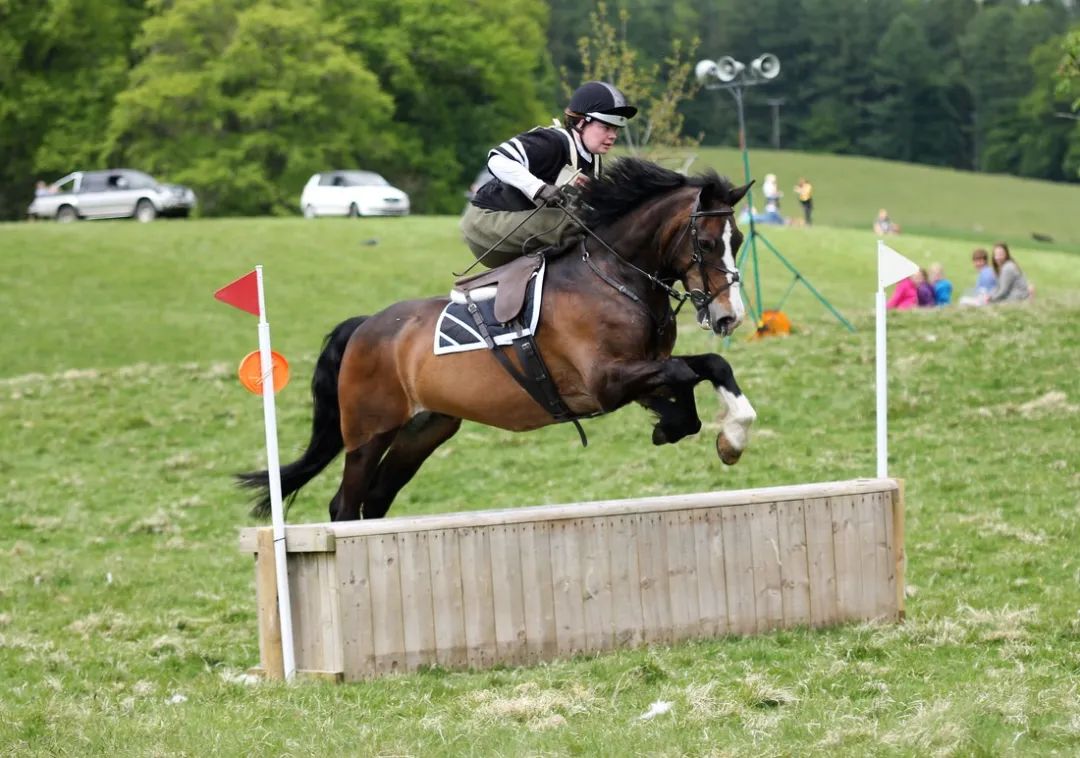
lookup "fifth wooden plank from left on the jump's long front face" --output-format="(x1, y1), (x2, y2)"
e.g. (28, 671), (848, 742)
(458, 527), (496, 668)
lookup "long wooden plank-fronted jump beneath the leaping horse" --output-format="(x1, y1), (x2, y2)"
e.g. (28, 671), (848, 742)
(240, 479), (904, 681)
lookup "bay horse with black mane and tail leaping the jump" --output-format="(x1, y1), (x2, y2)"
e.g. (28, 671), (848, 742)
(238, 158), (756, 520)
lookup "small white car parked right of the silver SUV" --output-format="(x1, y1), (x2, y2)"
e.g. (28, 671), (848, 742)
(300, 171), (409, 218)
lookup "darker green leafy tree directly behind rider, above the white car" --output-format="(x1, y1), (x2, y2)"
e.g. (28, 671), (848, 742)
(326, 0), (548, 212)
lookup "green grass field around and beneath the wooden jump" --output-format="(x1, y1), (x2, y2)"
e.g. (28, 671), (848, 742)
(0, 194), (1080, 756)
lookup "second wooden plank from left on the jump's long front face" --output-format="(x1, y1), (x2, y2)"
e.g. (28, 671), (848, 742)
(367, 534), (405, 674)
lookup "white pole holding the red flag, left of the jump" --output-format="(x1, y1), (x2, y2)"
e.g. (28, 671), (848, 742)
(255, 266), (296, 681)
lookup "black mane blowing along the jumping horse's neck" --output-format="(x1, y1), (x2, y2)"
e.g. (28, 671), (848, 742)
(581, 158), (734, 228)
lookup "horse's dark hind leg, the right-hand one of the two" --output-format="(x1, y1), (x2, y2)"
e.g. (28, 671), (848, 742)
(364, 411), (461, 518)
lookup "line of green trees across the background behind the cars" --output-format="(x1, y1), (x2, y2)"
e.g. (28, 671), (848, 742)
(0, 0), (1080, 218)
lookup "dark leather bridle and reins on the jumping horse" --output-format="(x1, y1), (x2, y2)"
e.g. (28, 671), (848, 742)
(578, 191), (739, 321)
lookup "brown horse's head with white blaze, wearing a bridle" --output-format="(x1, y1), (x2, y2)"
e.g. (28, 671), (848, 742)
(671, 179), (753, 335)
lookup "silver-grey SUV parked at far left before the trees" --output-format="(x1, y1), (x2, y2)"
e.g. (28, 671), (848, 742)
(27, 168), (195, 221)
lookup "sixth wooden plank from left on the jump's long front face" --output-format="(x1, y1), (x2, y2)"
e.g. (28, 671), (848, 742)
(488, 524), (526, 665)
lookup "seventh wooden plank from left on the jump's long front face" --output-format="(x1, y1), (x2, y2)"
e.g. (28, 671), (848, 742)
(517, 523), (558, 663)
